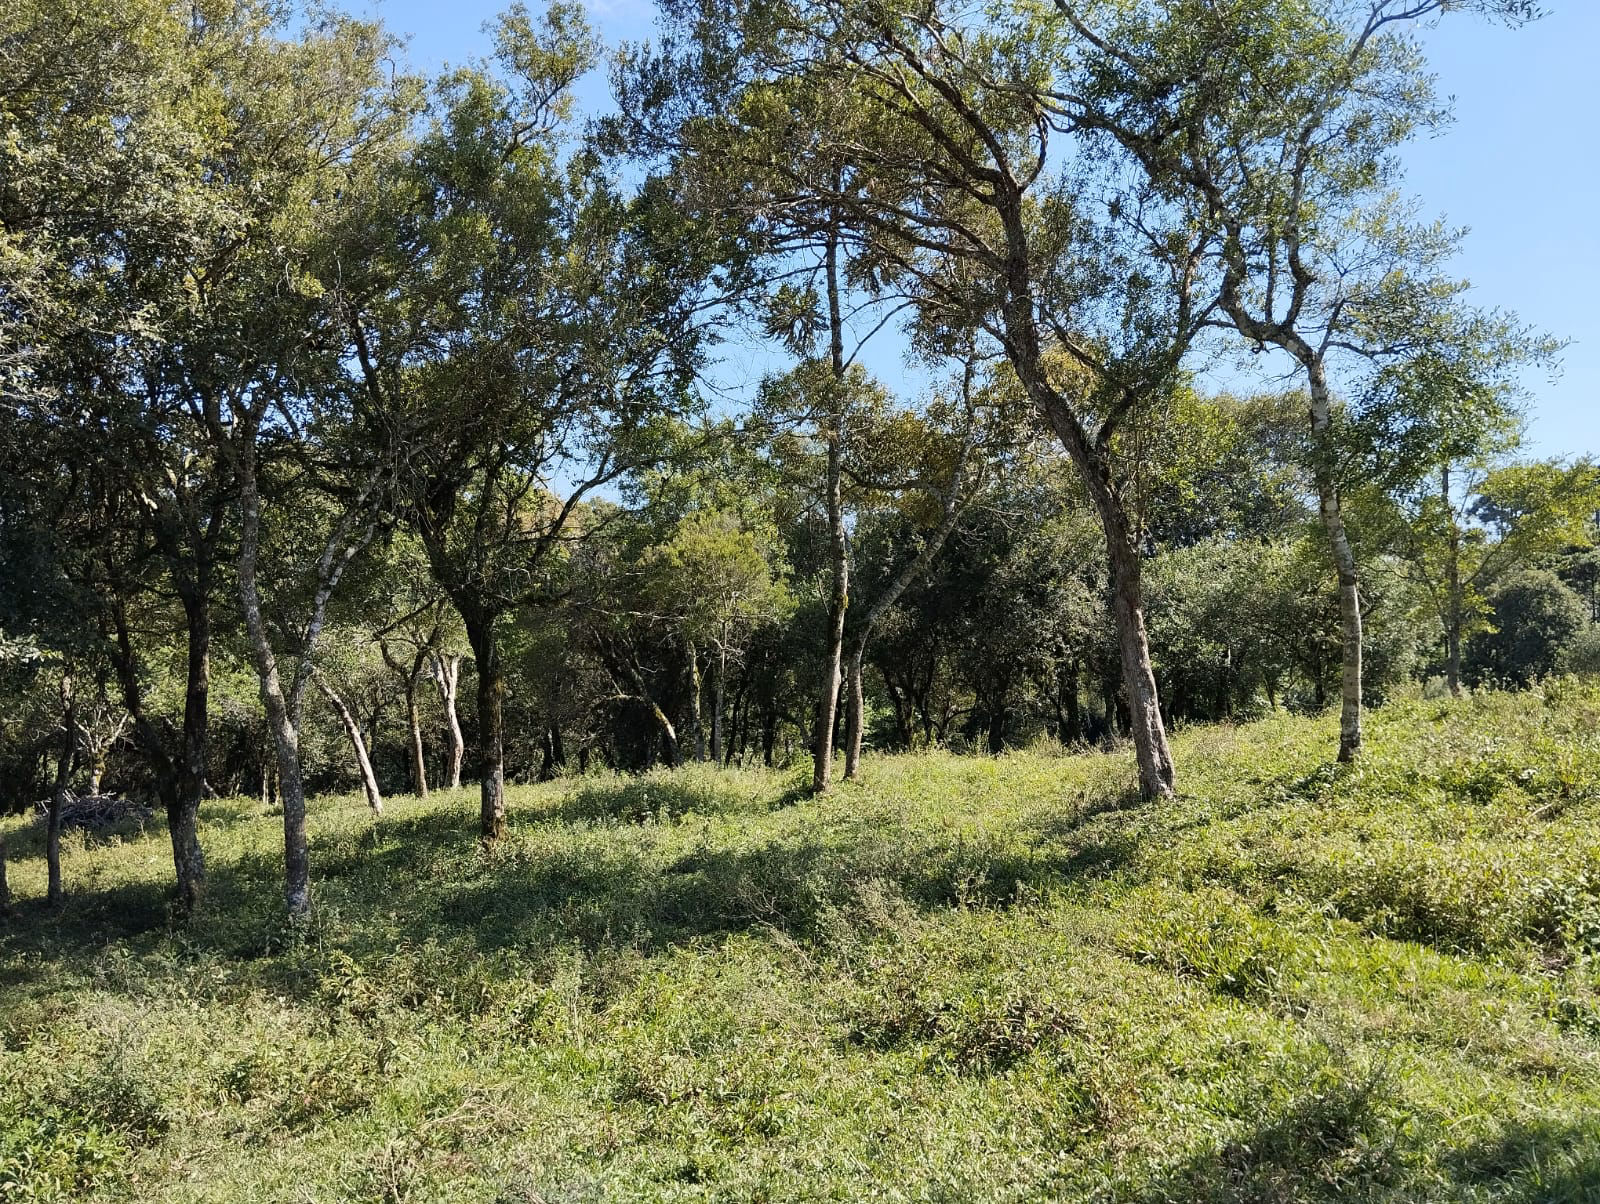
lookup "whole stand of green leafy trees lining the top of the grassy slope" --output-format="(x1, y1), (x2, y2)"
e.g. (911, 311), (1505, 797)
(0, 0), (1600, 916)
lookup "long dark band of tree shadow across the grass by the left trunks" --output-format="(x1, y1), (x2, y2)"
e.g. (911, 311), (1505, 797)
(0, 775), (1136, 993)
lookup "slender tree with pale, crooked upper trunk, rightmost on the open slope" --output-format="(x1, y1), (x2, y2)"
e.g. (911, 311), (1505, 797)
(1056, 0), (1536, 761)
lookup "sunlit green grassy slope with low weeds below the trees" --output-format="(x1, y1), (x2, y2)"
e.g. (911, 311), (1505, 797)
(0, 685), (1600, 1202)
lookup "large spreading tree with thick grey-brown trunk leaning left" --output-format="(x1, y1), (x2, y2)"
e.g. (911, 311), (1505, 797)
(633, 0), (1248, 796)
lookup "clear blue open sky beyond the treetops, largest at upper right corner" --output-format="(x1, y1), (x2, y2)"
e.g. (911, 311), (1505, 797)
(366, 0), (1600, 456)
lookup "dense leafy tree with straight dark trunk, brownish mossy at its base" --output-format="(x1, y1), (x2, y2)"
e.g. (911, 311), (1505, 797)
(341, 5), (714, 841)
